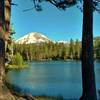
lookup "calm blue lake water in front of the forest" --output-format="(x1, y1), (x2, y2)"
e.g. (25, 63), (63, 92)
(7, 61), (100, 98)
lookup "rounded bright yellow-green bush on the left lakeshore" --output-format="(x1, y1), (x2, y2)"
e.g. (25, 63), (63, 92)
(11, 53), (23, 66)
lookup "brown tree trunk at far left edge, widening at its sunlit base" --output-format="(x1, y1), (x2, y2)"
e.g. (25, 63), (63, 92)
(0, 0), (15, 100)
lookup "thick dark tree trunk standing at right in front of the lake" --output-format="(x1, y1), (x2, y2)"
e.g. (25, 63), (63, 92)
(80, 0), (97, 100)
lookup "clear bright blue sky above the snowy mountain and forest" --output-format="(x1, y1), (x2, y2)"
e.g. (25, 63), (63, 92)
(11, 0), (100, 41)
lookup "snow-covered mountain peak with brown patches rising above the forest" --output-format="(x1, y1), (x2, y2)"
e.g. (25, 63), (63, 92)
(15, 32), (50, 44)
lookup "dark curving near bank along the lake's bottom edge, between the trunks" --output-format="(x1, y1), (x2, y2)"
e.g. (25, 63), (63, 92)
(5, 81), (79, 100)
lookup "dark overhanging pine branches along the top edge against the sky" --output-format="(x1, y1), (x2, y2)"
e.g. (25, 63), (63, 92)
(31, 0), (100, 13)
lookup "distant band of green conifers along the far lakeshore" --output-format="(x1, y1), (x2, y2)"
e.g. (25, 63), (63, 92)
(13, 38), (100, 61)
